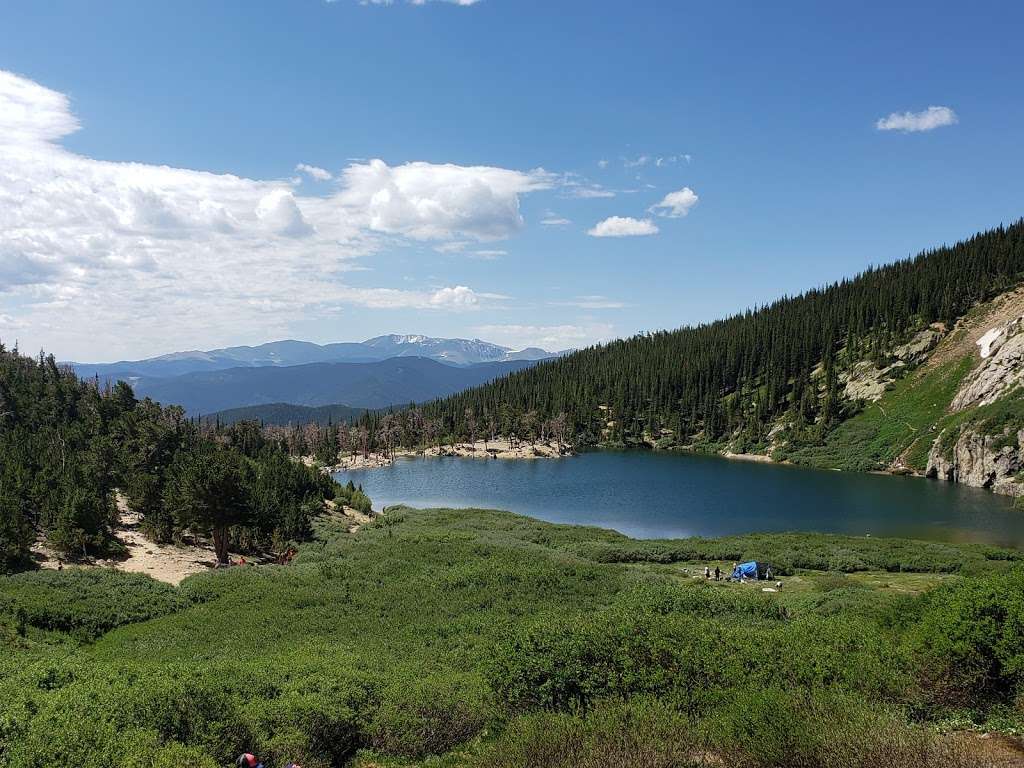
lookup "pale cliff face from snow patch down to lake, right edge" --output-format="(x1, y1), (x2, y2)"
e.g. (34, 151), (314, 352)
(926, 317), (1024, 496)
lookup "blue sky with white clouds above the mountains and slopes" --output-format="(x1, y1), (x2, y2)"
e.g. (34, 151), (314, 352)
(0, 0), (1024, 360)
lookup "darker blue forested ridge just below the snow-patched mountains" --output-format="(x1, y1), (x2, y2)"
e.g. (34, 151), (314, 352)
(131, 357), (536, 415)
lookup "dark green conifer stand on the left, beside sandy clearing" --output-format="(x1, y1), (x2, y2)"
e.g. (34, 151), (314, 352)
(0, 345), (356, 571)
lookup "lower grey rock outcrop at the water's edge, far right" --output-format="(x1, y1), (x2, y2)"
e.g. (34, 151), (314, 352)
(926, 427), (1024, 496)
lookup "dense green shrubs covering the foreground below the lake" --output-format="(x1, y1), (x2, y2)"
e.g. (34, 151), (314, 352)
(0, 508), (1024, 768)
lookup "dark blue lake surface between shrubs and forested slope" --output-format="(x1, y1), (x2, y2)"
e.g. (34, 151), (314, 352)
(336, 452), (1024, 547)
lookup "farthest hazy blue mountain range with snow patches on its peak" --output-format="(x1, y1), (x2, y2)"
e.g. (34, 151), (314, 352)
(70, 334), (564, 383)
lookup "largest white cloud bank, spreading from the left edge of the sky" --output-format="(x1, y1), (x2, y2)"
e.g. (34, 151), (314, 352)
(0, 71), (536, 359)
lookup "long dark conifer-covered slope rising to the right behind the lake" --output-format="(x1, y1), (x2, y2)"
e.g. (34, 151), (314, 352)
(424, 220), (1024, 447)
